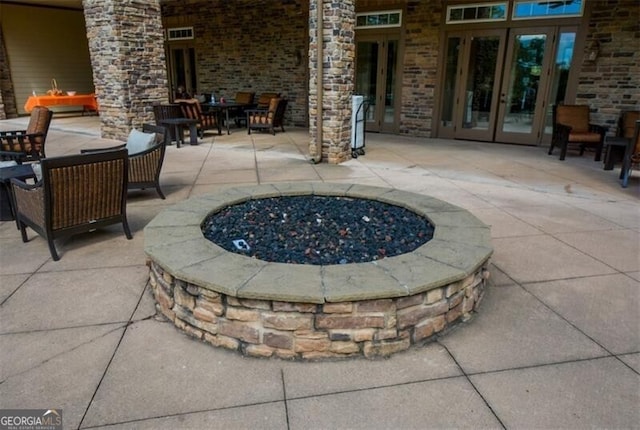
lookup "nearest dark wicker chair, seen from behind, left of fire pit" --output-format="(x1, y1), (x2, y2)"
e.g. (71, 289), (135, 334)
(11, 150), (132, 261)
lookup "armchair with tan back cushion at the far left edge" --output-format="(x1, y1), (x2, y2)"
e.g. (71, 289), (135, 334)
(0, 106), (53, 161)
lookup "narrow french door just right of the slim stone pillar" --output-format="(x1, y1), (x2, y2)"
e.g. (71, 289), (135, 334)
(355, 35), (400, 132)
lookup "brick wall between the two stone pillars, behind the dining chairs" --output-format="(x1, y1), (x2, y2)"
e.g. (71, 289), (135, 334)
(162, 0), (309, 127)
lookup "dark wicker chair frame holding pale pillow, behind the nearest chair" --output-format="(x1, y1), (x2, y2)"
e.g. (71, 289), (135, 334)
(80, 124), (171, 200)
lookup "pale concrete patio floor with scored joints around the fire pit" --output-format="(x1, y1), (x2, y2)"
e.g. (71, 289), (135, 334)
(0, 115), (640, 430)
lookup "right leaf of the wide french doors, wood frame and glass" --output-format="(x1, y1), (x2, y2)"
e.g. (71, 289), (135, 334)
(495, 28), (553, 145)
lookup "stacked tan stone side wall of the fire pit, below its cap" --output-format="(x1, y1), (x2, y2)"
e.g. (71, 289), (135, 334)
(150, 262), (488, 359)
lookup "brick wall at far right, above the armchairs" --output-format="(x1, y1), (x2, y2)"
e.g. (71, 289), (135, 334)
(576, 0), (640, 134)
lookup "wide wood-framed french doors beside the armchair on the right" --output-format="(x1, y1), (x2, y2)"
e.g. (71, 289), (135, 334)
(438, 27), (575, 145)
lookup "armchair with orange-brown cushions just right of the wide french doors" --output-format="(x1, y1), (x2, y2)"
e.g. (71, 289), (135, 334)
(549, 105), (607, 161)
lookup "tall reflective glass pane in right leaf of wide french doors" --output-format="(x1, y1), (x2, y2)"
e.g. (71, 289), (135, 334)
(502, 34), (547, 134)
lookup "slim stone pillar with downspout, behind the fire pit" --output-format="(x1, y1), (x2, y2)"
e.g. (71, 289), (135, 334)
(309, 0), (356, 164)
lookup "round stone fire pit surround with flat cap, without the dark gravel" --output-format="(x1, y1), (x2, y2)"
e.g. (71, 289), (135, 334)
(144, 183), (493, 359)
